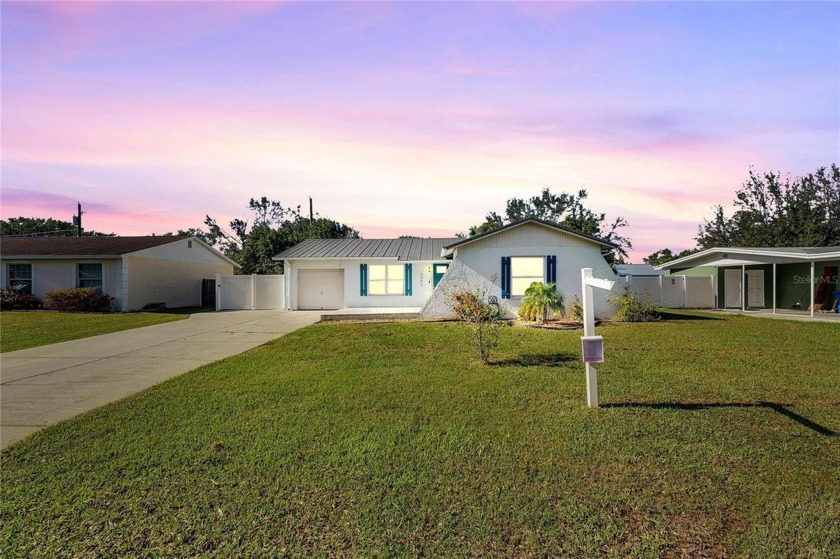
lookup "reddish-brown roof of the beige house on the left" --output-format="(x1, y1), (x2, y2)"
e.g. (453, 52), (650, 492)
(0, 235), (187, 256)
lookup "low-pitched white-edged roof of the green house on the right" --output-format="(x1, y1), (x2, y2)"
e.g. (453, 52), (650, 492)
(656, 246), (840, 270)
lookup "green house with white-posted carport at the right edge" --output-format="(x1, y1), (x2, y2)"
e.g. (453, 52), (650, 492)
(658, 246), (840, 316)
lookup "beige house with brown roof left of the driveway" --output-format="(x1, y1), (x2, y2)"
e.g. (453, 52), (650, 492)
(0, 236), (235, 311)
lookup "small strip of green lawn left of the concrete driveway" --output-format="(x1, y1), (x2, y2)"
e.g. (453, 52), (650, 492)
(0, 309), (194, 352)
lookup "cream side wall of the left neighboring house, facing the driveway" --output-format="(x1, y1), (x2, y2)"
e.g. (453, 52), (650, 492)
(119, 258), (233, 311)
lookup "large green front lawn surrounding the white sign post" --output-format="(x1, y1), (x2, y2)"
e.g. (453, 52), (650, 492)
(0, 312), (840, 557)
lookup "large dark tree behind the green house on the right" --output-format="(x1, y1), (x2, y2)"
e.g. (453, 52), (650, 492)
(696, 164), (840, 249)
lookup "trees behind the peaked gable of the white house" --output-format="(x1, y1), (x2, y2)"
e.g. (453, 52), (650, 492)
(469, 188), (633, 265)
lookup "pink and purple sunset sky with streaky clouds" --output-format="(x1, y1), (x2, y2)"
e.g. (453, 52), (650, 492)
(0, 1), (840, 262)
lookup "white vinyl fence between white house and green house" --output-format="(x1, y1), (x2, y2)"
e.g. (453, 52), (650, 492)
(624, 276), (715, 309)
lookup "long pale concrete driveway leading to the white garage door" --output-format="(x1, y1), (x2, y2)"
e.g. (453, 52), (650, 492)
(0, 311), (321, 448)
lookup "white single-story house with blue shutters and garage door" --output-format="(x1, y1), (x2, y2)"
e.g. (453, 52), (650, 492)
(274, 218), (616, 316)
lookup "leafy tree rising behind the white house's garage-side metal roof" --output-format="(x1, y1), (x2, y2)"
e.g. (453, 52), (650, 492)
(202, 196), (359, 274)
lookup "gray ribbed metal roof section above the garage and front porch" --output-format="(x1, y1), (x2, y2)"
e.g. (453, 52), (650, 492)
(274, 237), (458, 262)
